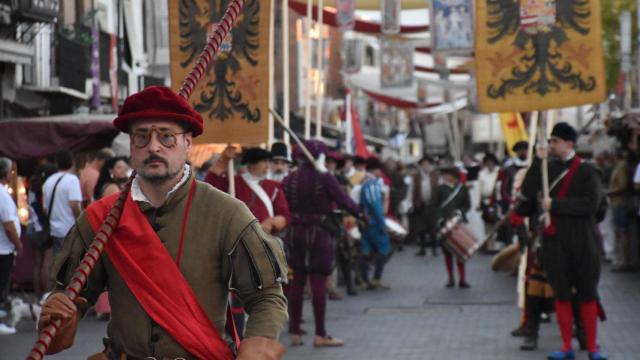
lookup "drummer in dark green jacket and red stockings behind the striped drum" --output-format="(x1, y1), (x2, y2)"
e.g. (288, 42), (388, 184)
(434, 166), (471, 289)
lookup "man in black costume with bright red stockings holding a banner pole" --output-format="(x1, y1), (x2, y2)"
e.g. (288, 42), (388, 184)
(517, 123), (606, 360)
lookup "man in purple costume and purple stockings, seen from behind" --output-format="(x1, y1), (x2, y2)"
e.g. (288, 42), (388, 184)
(282, 140), (361, 347)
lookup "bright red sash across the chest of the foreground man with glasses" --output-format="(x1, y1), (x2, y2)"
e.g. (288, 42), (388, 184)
(86, 181), (234, 360)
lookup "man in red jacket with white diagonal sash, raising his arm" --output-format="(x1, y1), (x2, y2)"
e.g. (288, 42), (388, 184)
(205, 146), (291, 337)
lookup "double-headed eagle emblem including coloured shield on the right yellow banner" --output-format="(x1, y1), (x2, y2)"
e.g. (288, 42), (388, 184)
(480, 0), (596, 99)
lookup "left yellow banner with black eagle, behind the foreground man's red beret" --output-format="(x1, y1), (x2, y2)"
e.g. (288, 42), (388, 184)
(169, 0), (270, 144)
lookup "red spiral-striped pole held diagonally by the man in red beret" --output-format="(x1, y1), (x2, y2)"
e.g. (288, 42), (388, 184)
(27, 0), (245, 360)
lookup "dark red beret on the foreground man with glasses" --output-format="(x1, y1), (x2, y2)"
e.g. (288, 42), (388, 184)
(113, 86), (204, 137)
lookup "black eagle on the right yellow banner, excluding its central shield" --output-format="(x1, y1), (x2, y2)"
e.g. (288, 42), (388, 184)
(485, 0), (596, 99)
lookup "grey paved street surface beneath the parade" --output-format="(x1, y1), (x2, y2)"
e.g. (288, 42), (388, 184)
(0, 248), (640, 360)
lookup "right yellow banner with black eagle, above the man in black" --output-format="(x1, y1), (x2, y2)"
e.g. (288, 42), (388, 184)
(475, 0), (606, 113)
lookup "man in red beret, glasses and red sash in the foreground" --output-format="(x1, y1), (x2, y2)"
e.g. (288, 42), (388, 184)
(39, 87), (287, 359)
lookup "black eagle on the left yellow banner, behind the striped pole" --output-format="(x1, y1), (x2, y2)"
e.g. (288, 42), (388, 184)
(179, 0), (261, 122)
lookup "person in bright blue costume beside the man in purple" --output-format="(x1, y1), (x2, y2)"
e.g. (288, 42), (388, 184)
(359, 157), (391, 290)
